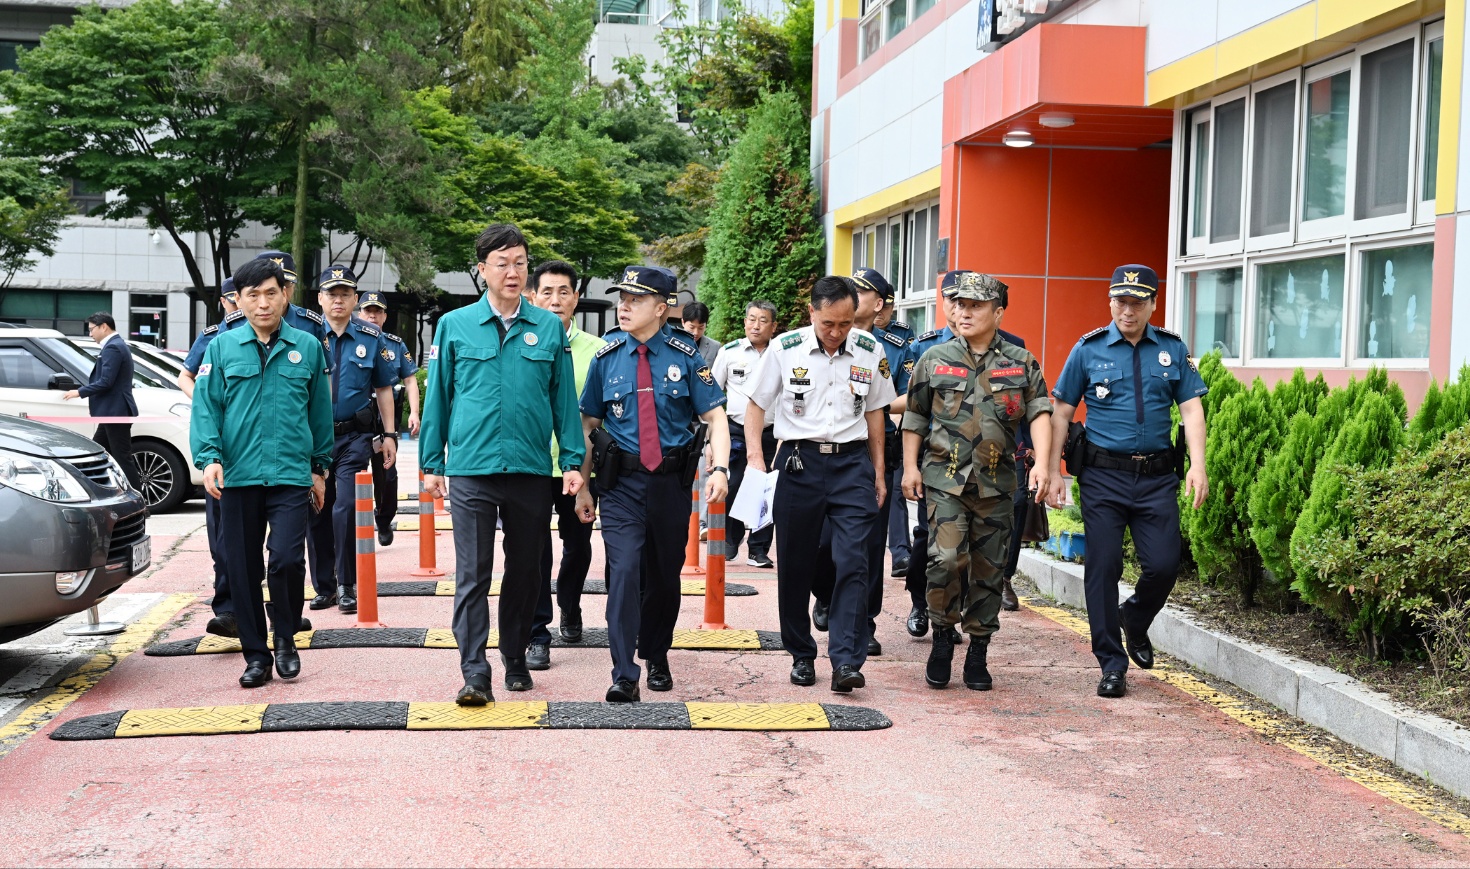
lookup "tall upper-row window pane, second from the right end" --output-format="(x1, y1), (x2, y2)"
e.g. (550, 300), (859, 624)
(1357, 40), (1414, 219)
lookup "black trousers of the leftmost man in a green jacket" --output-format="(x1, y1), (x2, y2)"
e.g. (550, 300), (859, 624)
(219, 485), (312, 666)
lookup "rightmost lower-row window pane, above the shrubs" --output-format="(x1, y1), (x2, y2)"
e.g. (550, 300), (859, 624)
(1357, 244), (1435, 359)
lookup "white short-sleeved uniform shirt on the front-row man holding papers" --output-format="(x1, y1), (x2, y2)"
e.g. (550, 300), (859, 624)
(746, 326), (898, 444)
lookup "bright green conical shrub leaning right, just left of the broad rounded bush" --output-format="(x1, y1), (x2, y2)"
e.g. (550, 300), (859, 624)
(1291, 391), (1404, 629)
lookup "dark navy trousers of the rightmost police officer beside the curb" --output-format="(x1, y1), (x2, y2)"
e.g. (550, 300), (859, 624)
(1079, 468), (1183, 672)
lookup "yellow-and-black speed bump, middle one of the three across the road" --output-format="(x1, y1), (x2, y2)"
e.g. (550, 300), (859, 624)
(144, 628), (785, 657)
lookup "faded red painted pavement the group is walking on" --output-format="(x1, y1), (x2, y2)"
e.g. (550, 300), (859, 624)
(0, 532), (1470, 866)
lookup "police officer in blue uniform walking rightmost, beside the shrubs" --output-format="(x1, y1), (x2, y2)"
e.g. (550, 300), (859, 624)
(1048, 265), (1210, 697)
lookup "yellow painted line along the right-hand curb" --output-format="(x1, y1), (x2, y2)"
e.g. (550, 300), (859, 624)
(1020, 597), (1470, 837)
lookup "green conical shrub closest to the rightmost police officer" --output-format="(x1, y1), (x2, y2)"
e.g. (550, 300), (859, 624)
(1183, 378), (1283, 606)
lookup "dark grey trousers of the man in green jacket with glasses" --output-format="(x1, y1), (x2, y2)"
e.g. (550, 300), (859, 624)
(450, 473), (557, 678)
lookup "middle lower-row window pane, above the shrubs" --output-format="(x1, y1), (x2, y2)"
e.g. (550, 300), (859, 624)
(1255, 254), (1344, 359)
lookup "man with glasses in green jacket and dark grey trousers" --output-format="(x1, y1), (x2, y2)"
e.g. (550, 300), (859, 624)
(419, 223), (587, 706)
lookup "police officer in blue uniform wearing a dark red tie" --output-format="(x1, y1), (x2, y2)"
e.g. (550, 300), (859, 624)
(578, 266), (731, 703)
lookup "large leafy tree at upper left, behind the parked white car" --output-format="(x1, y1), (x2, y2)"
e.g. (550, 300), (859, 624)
(0, 0), (281, 290)
